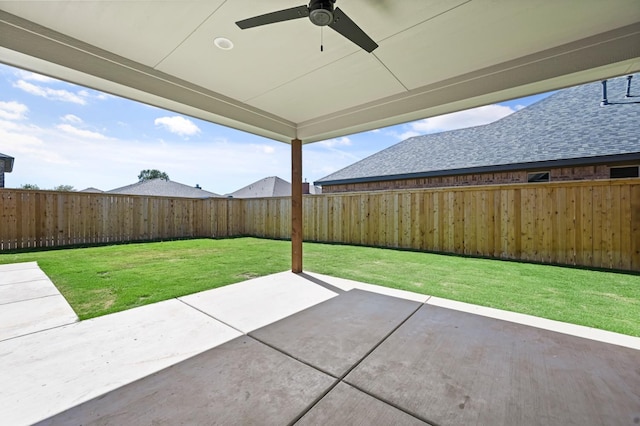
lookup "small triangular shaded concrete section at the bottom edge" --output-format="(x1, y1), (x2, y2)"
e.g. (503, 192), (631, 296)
(296, 382), (428, 426)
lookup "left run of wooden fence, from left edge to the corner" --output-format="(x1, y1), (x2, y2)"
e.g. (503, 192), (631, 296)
(0, 189), (243, 250)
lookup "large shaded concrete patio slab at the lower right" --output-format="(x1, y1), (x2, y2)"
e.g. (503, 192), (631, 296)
(345, 305), (640, 426)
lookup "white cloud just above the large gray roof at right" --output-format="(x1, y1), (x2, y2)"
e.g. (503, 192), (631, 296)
(399, 105), (515, 139)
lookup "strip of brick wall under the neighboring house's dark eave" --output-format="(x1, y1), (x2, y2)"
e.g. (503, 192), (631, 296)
(322, 164), (626, 194)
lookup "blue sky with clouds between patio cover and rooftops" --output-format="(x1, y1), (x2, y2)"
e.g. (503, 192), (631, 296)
(0, 64), (546, 194)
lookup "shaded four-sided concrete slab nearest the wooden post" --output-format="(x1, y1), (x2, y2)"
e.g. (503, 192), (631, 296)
(250, 289), (421, 377)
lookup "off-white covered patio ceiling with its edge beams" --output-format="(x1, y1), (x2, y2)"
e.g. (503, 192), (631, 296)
(0, 0), (640, 143)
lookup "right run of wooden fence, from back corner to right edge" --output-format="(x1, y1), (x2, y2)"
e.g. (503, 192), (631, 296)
(244, 179), (640, 271)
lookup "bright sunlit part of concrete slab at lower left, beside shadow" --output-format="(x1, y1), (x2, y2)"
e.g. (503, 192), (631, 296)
(0, 298), (241, 425)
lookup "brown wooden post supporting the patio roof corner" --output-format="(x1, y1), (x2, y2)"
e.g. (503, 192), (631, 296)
(291, 139), (303, 274)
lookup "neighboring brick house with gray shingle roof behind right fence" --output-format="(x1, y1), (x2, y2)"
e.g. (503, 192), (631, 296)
(314, 75), (640, 193)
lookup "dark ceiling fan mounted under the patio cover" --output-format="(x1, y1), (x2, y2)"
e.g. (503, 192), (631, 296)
(236, 0), (378, 53)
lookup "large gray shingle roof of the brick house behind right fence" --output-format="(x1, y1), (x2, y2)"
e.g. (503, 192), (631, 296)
(314, 74), (640, 185)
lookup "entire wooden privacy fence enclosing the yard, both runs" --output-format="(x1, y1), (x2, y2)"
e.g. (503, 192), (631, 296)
(0, 179), (640, 271)
